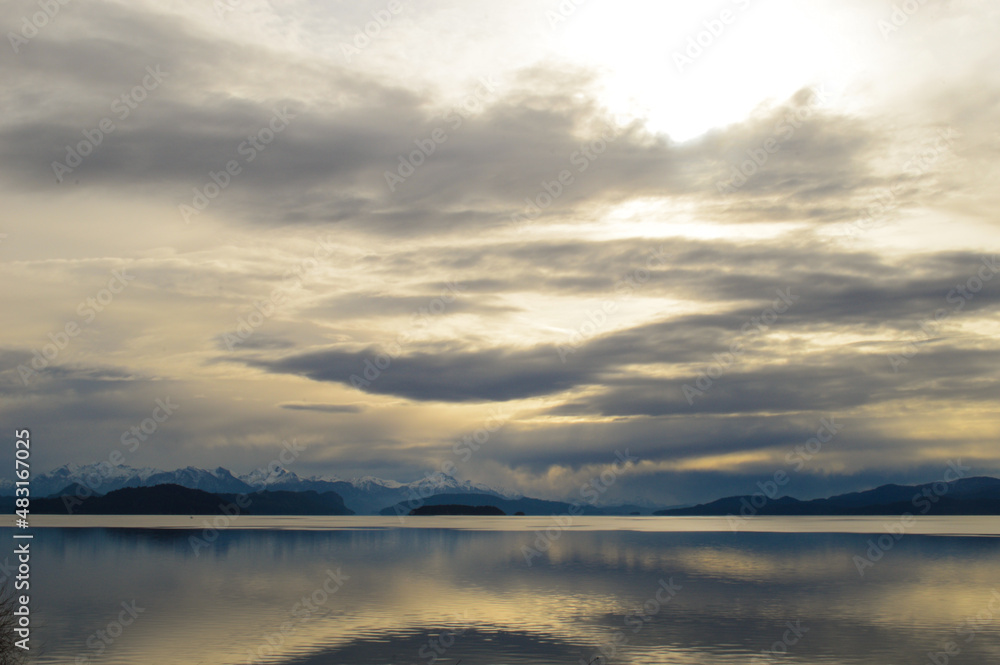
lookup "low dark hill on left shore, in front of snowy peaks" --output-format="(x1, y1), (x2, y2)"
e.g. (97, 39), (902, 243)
(24, 484), (354, 515)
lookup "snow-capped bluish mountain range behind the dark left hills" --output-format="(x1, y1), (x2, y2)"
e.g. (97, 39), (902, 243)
(19, 462), (522, 514)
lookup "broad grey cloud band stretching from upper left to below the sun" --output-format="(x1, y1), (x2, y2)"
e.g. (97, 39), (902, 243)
(0, 3), (908, 239)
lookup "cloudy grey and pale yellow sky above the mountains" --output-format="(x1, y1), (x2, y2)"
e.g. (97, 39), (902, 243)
(0, 0), (1000, 504)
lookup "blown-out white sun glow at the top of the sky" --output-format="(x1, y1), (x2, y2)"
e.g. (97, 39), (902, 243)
(556, 0), (859, 141)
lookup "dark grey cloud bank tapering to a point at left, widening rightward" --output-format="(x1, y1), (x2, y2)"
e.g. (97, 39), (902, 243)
(236, 243), (1000, 415)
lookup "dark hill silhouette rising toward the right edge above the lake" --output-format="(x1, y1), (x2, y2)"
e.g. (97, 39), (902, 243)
(653, 476), (1000, 516)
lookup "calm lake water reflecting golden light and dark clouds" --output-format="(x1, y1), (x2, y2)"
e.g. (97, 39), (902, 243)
(11, 517), (1000, 665)
